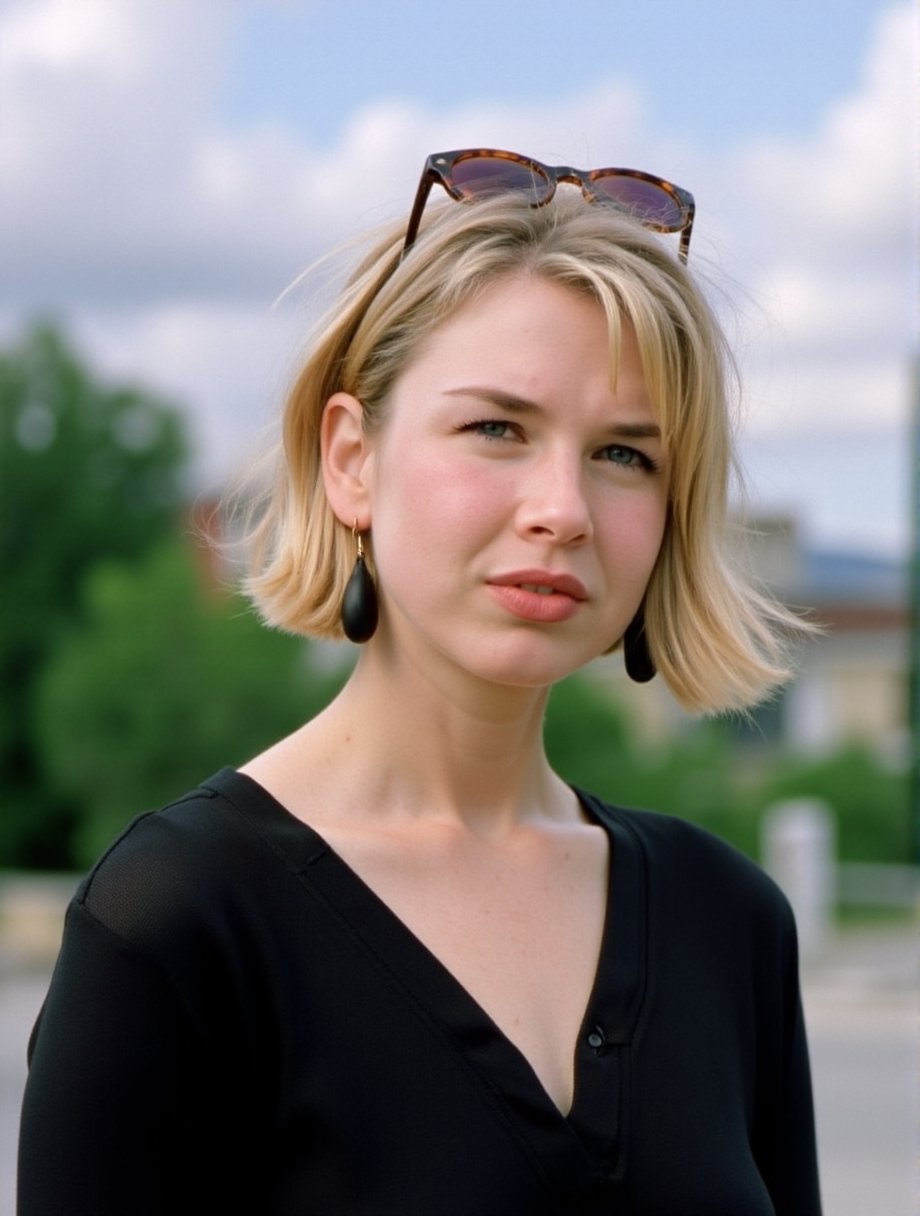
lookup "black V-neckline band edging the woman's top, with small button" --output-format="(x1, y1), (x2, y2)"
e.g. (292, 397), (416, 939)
(207, 769), (645, 1164)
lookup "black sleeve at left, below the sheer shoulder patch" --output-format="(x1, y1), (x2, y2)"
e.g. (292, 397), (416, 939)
(18, 903), (217, 1216)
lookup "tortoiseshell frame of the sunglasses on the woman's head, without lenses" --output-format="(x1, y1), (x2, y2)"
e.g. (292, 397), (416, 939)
(402, 148), (696, 263)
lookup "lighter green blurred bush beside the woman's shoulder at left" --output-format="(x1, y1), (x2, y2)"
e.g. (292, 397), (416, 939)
(38, 542), (343, 868)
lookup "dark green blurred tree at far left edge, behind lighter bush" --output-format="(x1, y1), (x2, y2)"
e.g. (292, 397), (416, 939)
(0, 326), (186, 866)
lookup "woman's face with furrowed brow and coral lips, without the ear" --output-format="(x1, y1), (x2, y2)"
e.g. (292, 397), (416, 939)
(367, 276), (667, 687)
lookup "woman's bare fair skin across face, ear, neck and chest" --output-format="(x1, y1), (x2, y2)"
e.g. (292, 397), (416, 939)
(243, 276), (667, 1111)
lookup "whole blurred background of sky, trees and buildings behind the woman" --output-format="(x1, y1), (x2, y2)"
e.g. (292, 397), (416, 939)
(0, 0), (920, 1216)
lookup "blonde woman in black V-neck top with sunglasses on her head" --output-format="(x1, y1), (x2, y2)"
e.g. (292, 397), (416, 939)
(19, 150), (819, 1216)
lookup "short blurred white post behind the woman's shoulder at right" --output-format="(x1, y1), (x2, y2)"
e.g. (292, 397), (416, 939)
(761, 798), (836, 958)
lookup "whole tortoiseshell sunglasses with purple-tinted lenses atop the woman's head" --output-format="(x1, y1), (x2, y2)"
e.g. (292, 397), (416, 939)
(402, 148), (696, 261)
